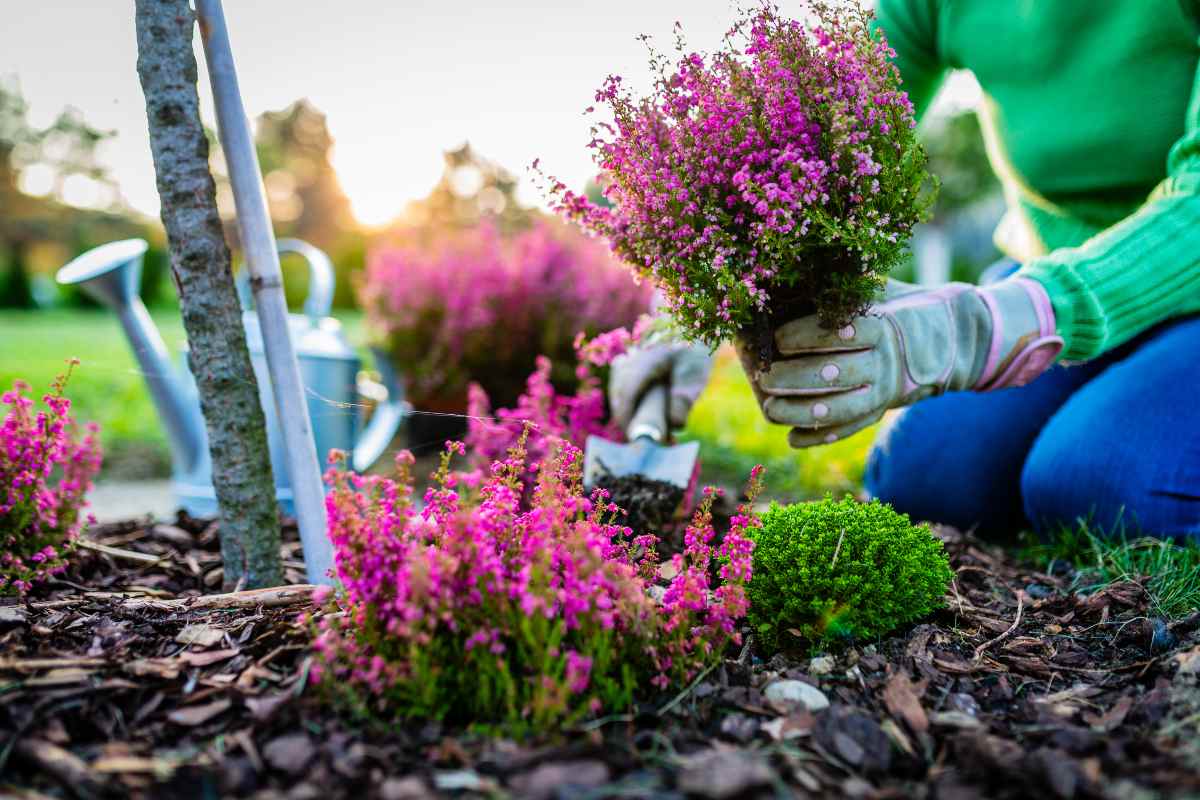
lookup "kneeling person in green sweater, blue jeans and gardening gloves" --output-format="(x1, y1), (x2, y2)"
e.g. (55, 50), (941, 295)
(611, 0), (1200, 536)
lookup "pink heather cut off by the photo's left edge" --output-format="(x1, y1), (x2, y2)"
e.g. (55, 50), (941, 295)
(0, 369), (101, 595)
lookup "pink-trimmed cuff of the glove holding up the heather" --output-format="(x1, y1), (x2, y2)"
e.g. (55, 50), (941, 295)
(972, 278), (1063, 392)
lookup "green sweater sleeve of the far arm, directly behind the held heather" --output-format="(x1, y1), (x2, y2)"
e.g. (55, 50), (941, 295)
(874, 0), (947, 121)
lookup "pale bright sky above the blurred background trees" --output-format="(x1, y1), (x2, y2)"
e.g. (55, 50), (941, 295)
(0, 0), (978, 224)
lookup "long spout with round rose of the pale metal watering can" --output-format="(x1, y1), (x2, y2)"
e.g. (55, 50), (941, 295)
(55, 239), (204, 473)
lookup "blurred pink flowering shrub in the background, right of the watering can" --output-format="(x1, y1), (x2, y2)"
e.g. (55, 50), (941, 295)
(360, 218), (650, 411)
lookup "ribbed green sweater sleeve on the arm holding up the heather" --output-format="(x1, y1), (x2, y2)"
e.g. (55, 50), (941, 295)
(1020, 45), (1200, 361)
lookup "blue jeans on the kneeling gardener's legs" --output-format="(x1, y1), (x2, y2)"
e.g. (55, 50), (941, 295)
(865, 287), (1200, 539)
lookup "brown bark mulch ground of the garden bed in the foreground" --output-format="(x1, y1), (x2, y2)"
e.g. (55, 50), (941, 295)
(0, 518), (1200, 800)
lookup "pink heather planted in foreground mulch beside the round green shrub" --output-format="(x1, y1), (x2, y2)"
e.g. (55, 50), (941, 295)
(312, 440), (760, 733)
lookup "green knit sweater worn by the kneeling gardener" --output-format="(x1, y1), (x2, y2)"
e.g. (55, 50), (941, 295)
(877, 0), (1200, 360)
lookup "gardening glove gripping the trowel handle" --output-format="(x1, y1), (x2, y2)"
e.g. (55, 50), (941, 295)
(608, 341), (713, 438)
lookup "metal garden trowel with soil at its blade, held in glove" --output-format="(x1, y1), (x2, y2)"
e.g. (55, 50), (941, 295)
(583, 384), (700, 489)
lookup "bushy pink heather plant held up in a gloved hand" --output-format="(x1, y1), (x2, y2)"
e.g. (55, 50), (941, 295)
(549, 0), (931, 352)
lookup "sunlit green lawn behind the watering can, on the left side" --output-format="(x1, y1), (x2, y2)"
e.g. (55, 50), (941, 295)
(0, 309), (361, 477)
